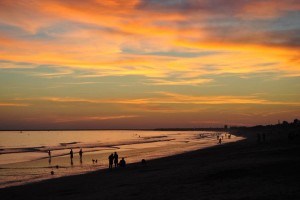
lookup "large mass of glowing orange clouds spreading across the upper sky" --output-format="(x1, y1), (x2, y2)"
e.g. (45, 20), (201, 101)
(0, 0), (299, 79)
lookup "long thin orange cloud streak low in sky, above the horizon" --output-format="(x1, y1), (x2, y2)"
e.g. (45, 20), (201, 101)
(14, 92), (300, 106)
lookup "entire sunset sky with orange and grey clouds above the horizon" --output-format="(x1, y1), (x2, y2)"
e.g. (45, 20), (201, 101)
(0, 0), (300, 130)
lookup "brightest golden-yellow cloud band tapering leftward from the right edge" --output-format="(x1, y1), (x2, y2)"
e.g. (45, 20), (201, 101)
(175, 41), (300, 76)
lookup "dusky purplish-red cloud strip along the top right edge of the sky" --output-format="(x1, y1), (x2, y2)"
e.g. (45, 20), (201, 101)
(139, 0), (300, 17)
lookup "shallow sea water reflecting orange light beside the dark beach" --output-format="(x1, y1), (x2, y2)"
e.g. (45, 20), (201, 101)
(0, 130), (241, 188)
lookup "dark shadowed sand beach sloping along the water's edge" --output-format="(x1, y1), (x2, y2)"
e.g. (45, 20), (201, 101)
(0, 130), (300, 200)
